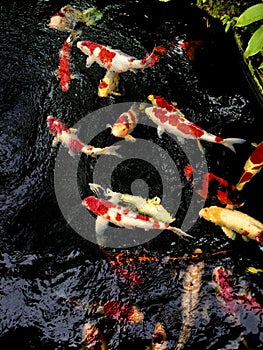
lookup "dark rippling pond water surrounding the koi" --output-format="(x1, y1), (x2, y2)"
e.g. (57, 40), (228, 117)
(0, 0), (263, 350)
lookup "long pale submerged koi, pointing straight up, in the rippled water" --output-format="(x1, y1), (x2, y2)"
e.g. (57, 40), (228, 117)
(175, 248), (204, 350)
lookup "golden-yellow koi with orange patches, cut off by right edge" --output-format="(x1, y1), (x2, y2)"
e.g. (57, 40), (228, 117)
(199, 206), (263, 243)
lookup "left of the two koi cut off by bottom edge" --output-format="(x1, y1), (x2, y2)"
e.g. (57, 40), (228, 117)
(81, 322), (108, 350)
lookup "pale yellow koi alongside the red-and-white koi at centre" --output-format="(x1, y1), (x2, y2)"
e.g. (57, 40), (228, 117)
(89, 183), (175, 224)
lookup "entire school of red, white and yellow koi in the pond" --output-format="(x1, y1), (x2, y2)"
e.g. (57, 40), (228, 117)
(47, 5), (263, 350)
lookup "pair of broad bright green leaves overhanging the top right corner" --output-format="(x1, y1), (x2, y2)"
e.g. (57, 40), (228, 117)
(236, 4), (263, 62)
